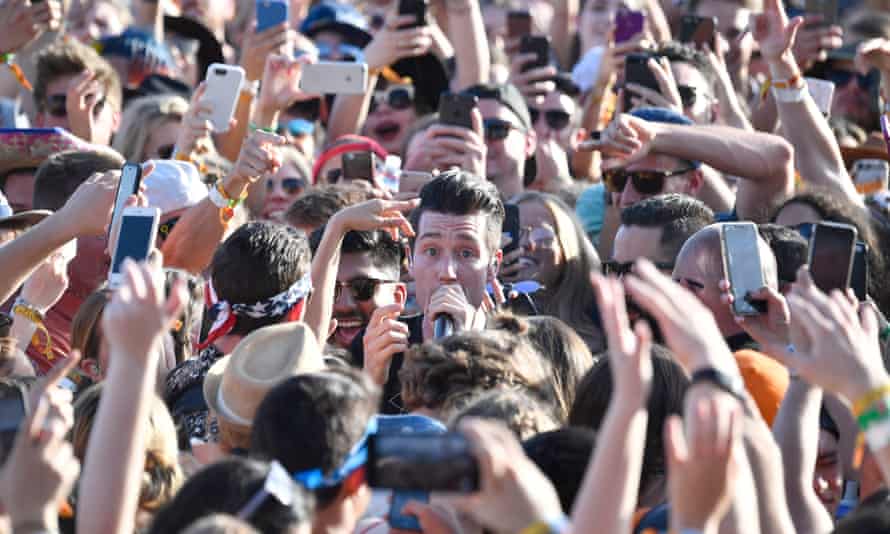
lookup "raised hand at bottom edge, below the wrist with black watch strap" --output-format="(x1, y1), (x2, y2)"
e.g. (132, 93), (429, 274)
(664, 397), (742, 532)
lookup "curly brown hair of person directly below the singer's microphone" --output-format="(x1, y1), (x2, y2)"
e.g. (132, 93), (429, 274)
(399, 330), (554, 415)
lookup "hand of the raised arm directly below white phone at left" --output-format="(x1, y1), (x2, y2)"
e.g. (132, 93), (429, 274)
(102, 259), (188, 366)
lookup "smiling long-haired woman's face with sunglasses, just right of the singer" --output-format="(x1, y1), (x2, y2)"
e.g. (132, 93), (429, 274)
(519, 201), (565, 287)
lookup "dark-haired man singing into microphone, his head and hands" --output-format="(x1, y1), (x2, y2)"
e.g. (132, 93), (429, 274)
(352, 170), (504, 413)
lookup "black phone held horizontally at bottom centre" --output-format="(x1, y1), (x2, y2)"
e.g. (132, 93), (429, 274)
(367, 433), (479, 493)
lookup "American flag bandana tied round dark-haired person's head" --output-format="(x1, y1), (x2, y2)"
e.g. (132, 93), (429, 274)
(198, 273), (312, 350)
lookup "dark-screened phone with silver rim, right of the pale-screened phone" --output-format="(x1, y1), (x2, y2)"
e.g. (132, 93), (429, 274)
(809, 222), (856, 293)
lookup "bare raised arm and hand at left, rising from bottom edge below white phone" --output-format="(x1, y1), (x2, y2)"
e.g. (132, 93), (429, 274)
(77, 260), (187, 533)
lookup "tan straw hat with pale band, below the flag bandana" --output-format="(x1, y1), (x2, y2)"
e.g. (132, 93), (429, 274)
(204, 322), (325, 428)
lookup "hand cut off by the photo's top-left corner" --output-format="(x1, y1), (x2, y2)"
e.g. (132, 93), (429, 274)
(0, 0), (62, 54)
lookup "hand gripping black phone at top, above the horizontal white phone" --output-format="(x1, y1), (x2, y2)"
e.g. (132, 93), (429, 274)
(365, 10), (433, 70)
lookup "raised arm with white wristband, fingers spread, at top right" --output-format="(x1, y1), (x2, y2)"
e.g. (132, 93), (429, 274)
(754, 0), (862, 206)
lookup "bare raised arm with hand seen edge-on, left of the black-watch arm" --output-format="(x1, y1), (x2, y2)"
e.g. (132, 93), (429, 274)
(572, 274), (652, 532)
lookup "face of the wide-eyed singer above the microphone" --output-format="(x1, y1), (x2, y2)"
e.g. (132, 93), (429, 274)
(411, 211), (501, 322)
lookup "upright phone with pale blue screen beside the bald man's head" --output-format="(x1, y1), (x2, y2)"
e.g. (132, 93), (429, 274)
(720, 222), (766, 315)
